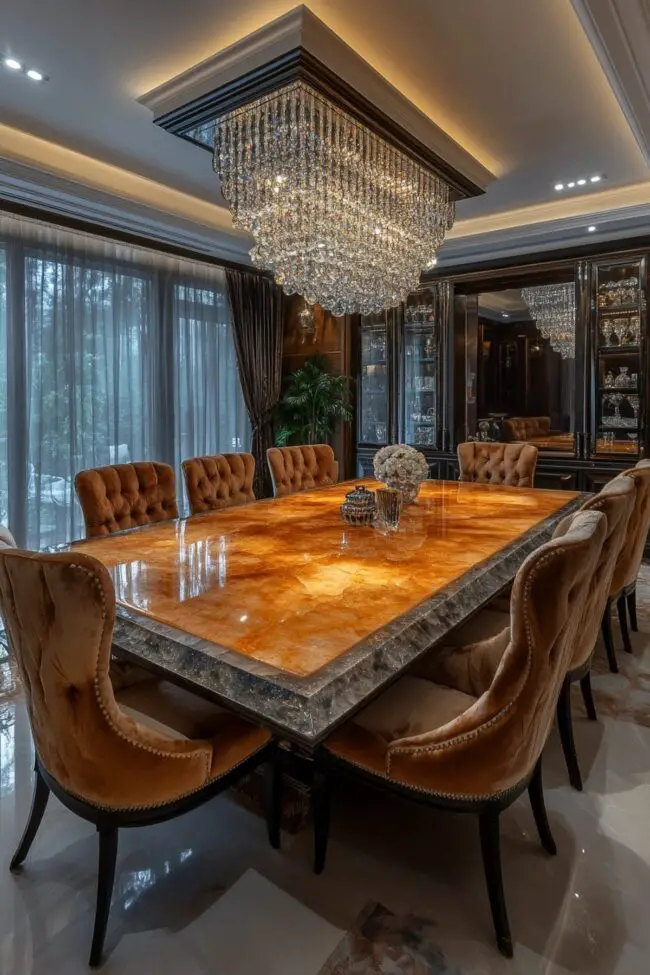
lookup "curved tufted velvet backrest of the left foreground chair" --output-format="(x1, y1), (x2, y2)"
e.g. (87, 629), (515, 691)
(0, 548), (212, 809)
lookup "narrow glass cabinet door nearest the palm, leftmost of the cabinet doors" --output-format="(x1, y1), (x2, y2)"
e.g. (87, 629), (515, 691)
(358, 314), (389, 444)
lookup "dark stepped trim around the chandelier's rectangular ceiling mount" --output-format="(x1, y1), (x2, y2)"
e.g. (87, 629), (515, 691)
(154, 47), (484, 200)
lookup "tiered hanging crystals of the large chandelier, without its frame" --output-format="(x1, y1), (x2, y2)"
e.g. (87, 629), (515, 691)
(214, 81), (454, 315)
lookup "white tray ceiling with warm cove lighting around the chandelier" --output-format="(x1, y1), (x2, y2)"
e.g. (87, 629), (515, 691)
(0, 0), (650, 262)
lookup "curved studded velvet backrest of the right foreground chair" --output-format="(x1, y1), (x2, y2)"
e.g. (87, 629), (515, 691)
(388, 511), (607, 800)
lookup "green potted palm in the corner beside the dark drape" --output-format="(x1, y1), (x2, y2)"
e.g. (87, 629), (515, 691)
(275, 355), (352, 447)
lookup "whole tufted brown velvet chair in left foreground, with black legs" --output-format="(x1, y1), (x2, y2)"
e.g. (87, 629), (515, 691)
(0, 549), (279, 965)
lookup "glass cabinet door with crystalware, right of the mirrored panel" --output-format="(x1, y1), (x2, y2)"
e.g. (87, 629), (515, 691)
(591, 260), (645, 460)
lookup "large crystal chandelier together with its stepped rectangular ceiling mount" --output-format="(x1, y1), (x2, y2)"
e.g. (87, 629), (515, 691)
(141, 6), (483, 315)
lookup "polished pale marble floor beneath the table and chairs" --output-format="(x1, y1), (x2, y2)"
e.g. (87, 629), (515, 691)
(0, 568), (650, 975)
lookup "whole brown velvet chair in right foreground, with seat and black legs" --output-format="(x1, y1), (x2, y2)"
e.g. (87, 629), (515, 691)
(302, 511), (607, 957)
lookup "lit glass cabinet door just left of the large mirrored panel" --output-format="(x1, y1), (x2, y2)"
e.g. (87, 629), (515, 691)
(403, 292), (440, 448)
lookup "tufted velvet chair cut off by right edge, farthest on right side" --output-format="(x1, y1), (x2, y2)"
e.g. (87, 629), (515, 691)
(603, 460), (650, 674)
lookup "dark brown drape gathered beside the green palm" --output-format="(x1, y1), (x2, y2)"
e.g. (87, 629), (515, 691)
(226, 270), (284, 498)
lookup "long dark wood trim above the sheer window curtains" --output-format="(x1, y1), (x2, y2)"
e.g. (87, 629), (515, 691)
(0, 197), (264, 277)
